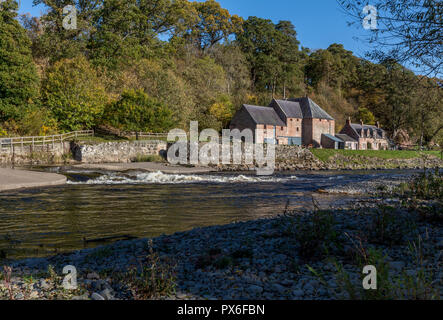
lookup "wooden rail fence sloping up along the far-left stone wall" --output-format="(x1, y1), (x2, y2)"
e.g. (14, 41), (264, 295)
(0, 130), (94, 149)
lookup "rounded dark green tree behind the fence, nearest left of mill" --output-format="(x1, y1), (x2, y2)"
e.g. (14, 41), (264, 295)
(104, 90), (174, 140)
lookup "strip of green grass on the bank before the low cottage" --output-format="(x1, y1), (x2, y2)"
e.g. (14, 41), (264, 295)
(310, 149), (440, 162)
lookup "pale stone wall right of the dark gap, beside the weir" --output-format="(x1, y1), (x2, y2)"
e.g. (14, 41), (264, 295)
(72, 141), (167, 163)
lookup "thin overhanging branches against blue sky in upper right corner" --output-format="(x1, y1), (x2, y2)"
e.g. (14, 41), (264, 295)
(337, 0), (443, 74)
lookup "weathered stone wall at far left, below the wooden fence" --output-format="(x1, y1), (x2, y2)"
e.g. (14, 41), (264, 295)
(0, 142), (71, 165)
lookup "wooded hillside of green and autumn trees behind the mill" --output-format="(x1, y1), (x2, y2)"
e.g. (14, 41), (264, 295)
(0, 0), (443, 145)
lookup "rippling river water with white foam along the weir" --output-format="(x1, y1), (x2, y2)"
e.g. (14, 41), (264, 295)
(0, 168), (412, 259)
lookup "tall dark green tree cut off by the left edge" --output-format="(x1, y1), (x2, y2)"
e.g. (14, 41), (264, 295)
(0, 0), (39, 122)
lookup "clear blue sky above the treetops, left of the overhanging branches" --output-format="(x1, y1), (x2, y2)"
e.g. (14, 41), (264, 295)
(20, 0), (369, 57)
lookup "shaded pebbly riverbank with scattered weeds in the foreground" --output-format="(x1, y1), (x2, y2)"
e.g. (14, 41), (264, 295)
(0, 195), (443, 300)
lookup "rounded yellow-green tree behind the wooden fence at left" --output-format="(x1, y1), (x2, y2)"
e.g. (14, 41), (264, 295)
(42, 56), (108, 131)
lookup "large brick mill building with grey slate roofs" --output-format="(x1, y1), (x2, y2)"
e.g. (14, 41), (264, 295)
(230, 97), (335, 147)
